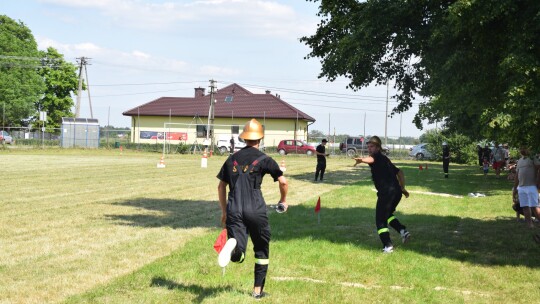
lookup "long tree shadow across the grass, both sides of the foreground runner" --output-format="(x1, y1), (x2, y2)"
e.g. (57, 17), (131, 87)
(108, 195), (540, 267)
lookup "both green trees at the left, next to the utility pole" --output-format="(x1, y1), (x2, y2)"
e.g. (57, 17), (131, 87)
(0, 15), (78, 129)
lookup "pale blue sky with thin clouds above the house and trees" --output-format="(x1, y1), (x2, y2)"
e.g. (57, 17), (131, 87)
(0, 0), (434, 138)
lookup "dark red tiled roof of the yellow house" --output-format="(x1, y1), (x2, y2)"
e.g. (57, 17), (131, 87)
(122, 83), (315, 122)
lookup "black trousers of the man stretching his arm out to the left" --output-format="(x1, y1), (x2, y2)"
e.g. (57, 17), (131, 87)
(375, 188), (406, 247)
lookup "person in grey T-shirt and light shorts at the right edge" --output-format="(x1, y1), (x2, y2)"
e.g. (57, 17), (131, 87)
(512, 147), (540, 228)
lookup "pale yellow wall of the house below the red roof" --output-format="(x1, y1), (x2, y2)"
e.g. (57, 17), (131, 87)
(131, 116), (308, 147)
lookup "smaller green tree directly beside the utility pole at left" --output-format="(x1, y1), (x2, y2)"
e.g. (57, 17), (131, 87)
(32, 47), (78, 128)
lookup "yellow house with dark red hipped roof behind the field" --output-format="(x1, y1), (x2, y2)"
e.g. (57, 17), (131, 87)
(123, 83), (315, 147)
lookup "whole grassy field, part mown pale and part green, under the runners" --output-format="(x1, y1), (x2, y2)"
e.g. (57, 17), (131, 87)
(0, 150), (540, 303)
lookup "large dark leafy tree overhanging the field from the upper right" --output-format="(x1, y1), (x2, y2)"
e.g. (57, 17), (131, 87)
(301, 0), (540, 146)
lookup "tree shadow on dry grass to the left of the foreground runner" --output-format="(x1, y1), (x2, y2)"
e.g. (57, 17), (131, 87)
(105, 198), (221, 229)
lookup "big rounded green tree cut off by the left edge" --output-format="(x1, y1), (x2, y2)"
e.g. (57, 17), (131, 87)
(0, 15), (44, 127)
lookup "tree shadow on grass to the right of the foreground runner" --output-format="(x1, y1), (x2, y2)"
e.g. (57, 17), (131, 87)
(270, 206), (540, 268)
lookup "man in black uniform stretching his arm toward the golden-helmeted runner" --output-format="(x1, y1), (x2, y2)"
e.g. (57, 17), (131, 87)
(354, 136), (411, 253)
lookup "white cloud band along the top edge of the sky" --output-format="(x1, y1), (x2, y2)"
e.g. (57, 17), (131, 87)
(38, 0), (316, 39)
